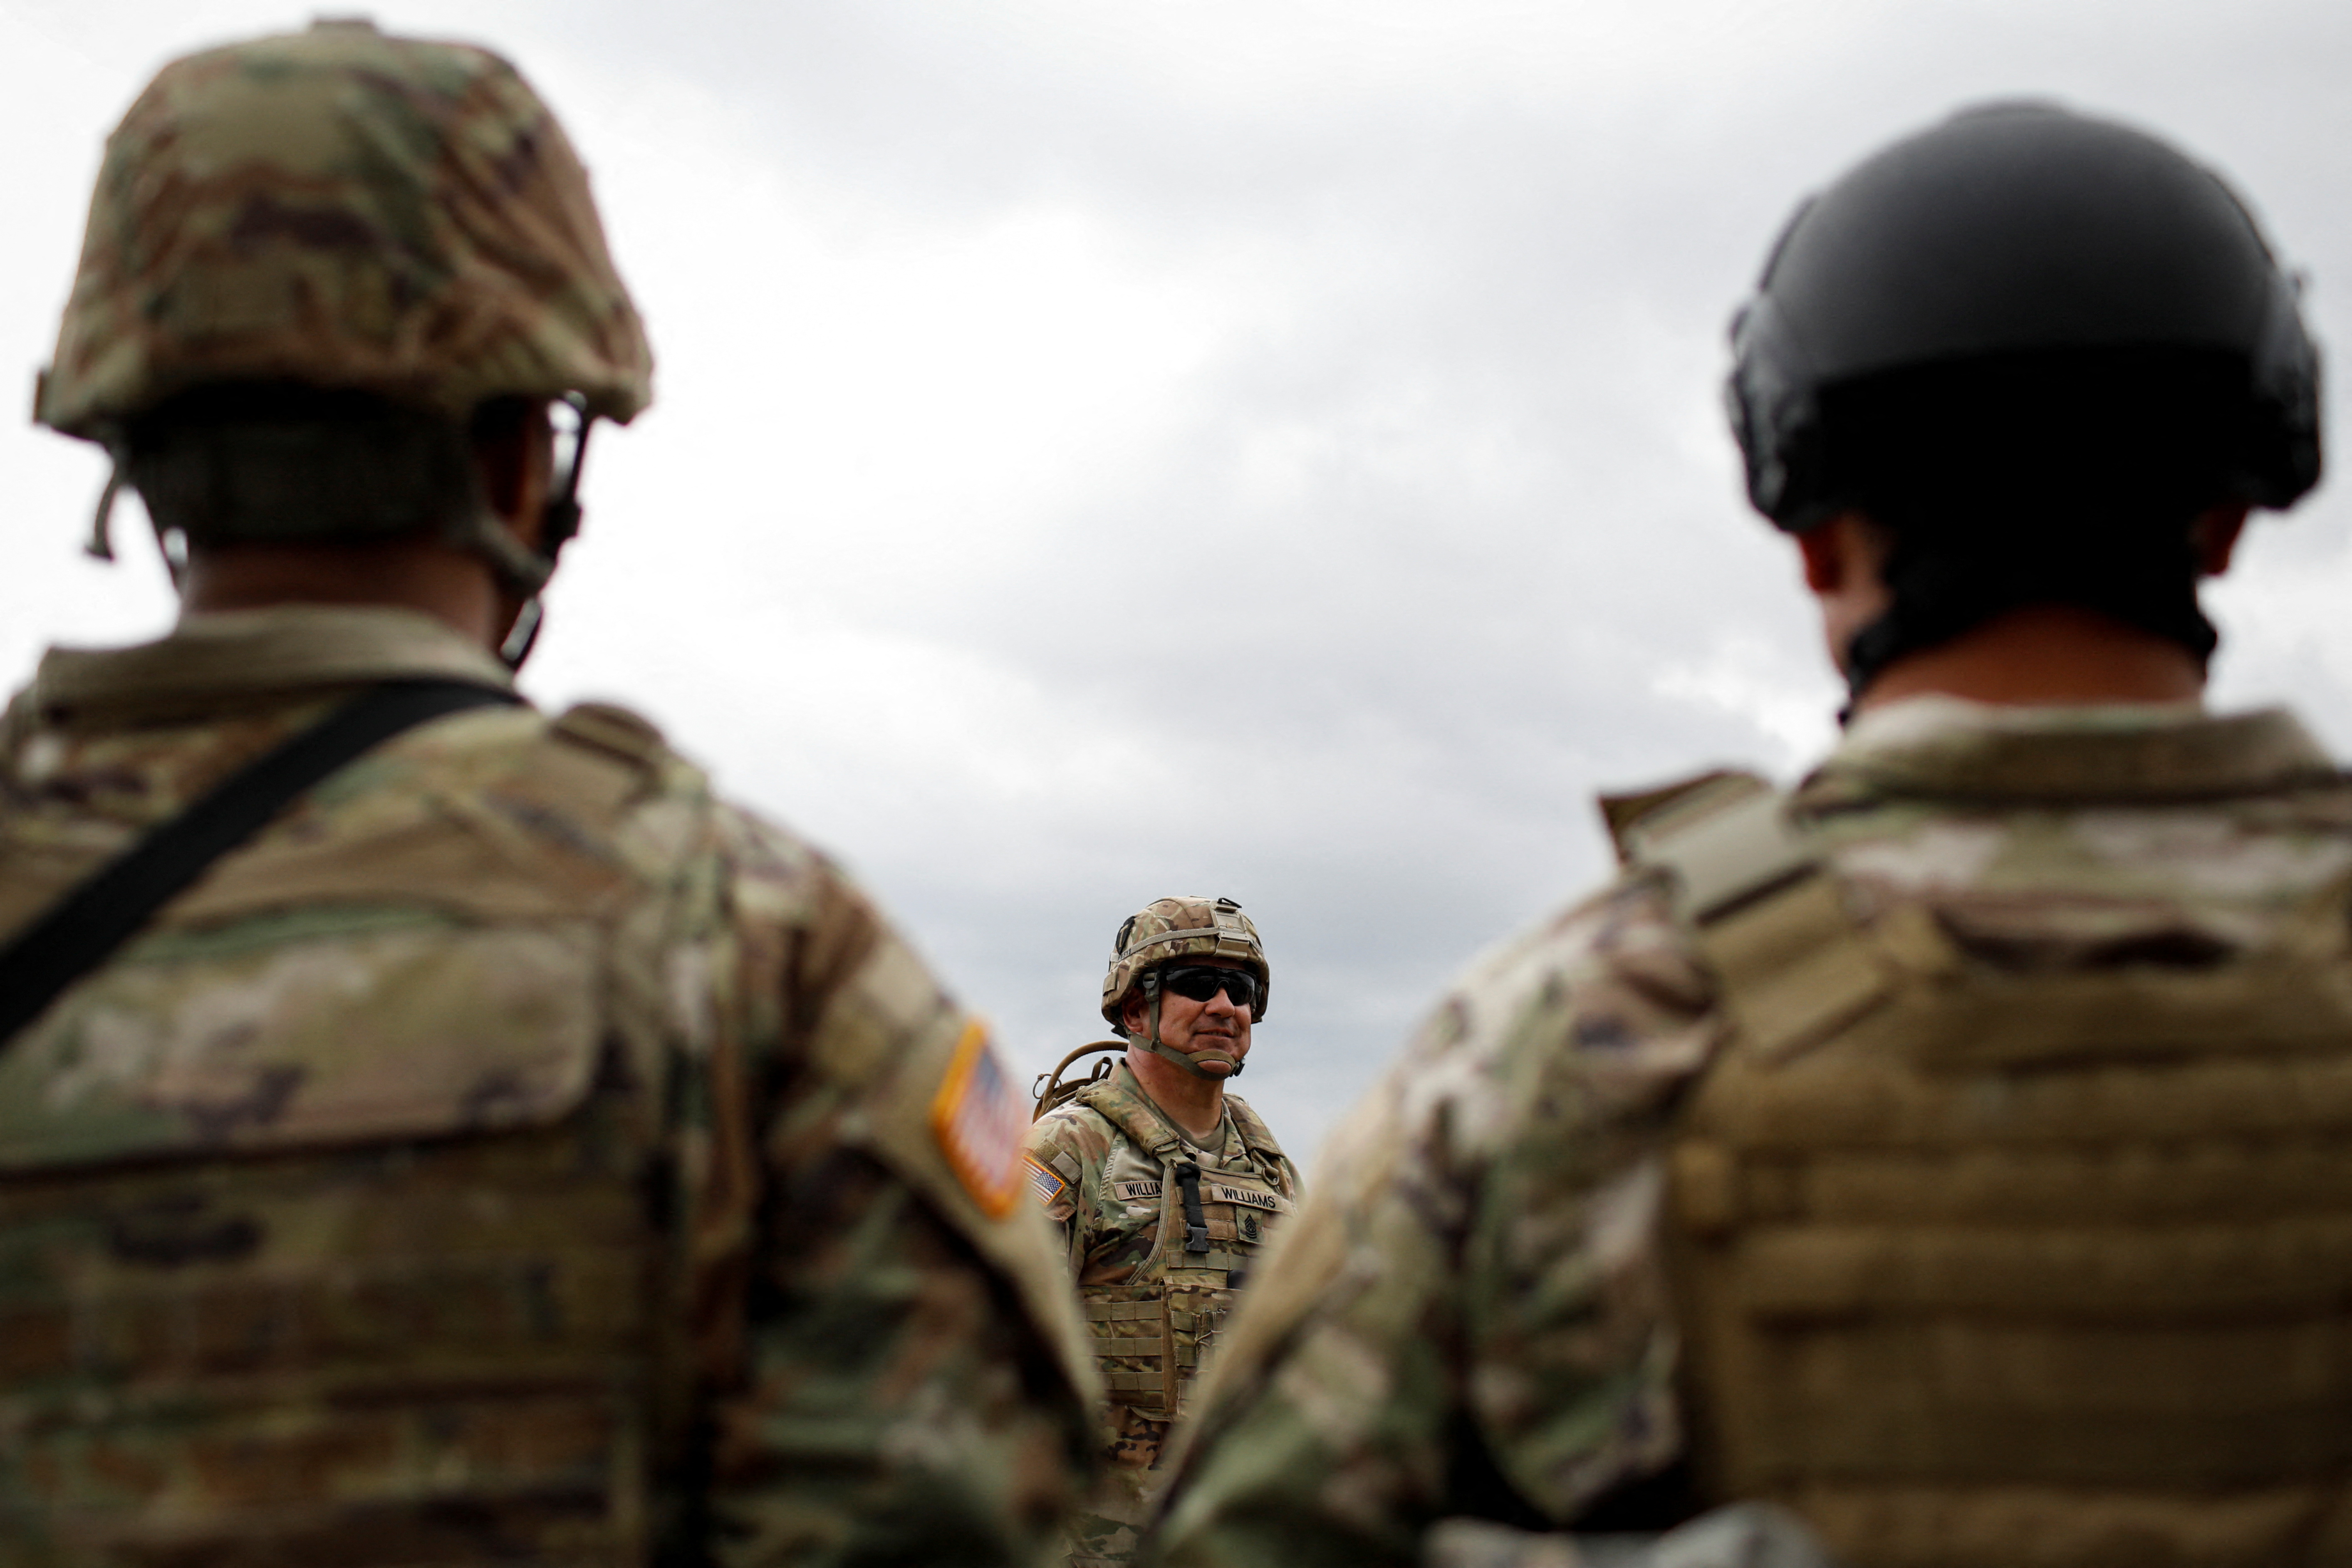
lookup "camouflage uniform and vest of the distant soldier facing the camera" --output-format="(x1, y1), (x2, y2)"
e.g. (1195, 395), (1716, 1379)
(1028, 1063), (1298, 1568)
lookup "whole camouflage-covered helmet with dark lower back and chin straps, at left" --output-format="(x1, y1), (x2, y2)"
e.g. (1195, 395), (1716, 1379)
(33, 21), (654, 658)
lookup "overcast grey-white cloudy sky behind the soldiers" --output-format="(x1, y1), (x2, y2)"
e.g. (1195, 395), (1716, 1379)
(0, 0), (2352, 1154)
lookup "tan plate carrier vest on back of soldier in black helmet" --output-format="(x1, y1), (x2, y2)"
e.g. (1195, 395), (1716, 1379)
(1618, 776), (2352, 1568)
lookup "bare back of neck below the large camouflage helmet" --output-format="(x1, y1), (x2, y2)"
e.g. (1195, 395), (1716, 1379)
(179, 538), (515, 651)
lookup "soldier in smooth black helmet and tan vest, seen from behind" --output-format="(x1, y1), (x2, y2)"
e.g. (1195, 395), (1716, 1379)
(1162, 106), (2352, 1568)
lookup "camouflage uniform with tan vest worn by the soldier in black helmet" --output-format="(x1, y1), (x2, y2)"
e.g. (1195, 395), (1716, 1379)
(1162, 698), (2352, 1568)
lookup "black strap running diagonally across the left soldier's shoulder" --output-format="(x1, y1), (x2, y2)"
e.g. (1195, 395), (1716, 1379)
(0, 679), (522, 1041)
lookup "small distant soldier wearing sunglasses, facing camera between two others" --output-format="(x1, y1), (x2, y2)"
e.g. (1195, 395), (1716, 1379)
(1028, 898), (1298, 1568)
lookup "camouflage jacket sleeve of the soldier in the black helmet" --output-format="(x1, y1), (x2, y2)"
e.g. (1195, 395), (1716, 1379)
(1159, 882), (1712, 1568)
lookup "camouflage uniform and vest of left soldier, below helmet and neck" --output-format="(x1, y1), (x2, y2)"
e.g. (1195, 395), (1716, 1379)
(0, 609), (1087, 1568)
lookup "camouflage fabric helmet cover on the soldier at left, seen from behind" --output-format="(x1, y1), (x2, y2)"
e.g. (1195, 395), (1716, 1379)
(33, 21), (651, 442)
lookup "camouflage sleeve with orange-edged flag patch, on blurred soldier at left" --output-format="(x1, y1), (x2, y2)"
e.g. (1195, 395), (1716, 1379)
(689, 818), (1091, 1563)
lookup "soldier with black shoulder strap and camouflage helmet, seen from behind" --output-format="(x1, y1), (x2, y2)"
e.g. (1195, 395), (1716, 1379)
(0, 24), (1094, 1568)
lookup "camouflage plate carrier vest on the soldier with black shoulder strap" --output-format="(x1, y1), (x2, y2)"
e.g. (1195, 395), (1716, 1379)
(0, 708), (743, 1568)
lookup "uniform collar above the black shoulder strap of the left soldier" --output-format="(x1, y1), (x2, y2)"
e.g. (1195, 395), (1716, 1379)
(33, 604), (515, 715)
